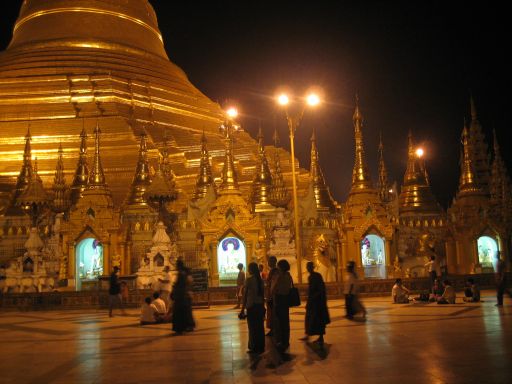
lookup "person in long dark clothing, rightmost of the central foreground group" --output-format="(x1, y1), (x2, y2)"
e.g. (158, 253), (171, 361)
(301, 261), (331, 345)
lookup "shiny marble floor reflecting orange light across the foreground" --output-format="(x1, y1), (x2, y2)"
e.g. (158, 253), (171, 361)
(0, 291), (512, 384)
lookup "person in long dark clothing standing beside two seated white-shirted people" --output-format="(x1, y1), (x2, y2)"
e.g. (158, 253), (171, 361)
(171, 260), (195, 334)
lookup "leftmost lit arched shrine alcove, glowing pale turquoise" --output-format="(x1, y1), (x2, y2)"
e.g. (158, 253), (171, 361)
(76, 238), (103, 290)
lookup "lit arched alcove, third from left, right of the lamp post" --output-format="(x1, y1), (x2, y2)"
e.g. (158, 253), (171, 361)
(360, 235), (387, 279)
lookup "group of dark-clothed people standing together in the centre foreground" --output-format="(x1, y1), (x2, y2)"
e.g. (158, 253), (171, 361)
(236, 256), (330, 354)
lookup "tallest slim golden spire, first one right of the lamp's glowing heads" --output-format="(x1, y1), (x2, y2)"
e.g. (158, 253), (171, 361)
(350, 95), (372, 193)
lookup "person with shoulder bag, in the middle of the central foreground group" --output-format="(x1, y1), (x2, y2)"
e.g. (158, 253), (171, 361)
(271, 259), (293, 352)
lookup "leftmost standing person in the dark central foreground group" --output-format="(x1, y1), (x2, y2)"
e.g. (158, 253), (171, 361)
(240, 263), (265, 354)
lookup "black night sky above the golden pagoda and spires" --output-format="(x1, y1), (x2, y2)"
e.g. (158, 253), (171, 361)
(0, 0), (512, 206)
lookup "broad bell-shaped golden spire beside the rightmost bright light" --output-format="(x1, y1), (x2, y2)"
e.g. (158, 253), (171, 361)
(399, 131), (441, 214)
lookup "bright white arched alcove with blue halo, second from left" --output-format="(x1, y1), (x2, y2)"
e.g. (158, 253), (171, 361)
(217, 237), (246, 286)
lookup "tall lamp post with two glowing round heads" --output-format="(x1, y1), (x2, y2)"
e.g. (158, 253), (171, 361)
(277, 93), (320, 283)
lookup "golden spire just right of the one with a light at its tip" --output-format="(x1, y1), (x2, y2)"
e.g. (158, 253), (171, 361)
(251, 126), (273, 212)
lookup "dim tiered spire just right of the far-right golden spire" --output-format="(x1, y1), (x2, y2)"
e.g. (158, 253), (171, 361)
(469, 95), (490, 193)
